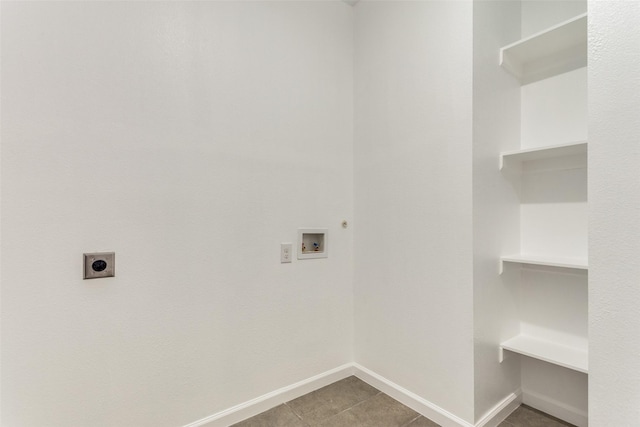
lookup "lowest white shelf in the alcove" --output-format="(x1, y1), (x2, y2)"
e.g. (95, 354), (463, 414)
(500, 335), (589, 374)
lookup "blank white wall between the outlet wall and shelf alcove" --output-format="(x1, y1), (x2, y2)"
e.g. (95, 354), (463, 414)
(354, 1), (474, 422)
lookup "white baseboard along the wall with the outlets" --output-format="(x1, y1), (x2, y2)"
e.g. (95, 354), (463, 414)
(184, 363), (354, 427)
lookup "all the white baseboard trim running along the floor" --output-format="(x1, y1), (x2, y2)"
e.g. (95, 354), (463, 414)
(184, 363), (524, 427)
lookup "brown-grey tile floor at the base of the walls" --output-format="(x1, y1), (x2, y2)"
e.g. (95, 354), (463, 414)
(233, 376), (571, 427)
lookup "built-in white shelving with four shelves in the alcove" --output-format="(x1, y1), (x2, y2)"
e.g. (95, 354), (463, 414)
(499, 13), (589, 426)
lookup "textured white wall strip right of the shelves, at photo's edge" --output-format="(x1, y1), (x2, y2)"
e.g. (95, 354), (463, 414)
(588, 1), (640, 426)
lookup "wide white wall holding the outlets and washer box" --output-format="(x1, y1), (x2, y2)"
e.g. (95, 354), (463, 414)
(1, 2), (353, 427)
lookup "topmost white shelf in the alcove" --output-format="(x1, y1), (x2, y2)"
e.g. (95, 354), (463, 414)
(500, 13), (587, 84)
